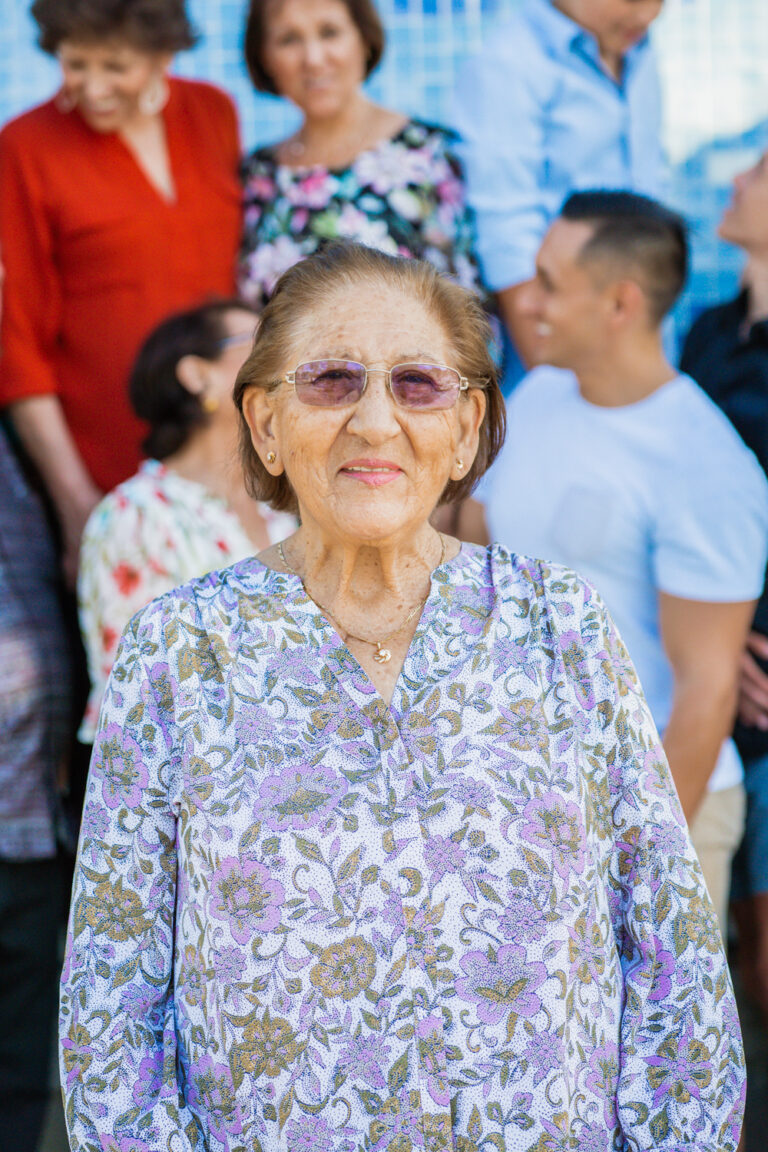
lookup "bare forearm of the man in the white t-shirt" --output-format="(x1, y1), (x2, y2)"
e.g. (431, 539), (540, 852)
(660, 592), (754, 823)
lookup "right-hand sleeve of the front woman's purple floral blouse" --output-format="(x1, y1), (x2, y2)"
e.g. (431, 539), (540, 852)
(558, 585), (745, 1152)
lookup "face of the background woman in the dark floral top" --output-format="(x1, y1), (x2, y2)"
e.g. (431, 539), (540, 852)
(264, 0), (366, 118)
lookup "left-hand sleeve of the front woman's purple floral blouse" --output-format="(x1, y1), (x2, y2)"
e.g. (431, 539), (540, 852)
(60, 609), (203, 1152)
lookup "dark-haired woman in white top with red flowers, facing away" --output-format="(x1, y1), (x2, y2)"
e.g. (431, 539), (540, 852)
(78, 301), (296, 744)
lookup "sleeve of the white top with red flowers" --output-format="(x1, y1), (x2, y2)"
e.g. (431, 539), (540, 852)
(77, 490), (178, 743)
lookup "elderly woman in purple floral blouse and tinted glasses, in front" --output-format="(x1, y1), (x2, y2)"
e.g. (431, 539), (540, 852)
(61, 245), (744, 1152)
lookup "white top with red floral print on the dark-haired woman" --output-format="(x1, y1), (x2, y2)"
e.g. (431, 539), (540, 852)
(77, 460), (296, 744)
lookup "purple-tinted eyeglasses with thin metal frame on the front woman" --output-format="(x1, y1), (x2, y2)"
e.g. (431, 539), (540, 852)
(284, 359), (470, 412)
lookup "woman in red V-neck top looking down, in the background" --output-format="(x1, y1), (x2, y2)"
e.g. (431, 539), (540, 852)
(0, 0), (242, 582)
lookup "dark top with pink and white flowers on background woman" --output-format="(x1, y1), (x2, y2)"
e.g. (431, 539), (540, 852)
(239, 120), (480, 304)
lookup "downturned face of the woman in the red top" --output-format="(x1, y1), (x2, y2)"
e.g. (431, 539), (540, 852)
(56, 40), (170, 132)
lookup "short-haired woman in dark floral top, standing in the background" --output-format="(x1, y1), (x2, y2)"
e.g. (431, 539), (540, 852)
(241, 0), (479, 303)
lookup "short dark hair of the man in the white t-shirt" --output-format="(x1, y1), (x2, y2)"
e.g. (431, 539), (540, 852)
(561, 189), (689, 324)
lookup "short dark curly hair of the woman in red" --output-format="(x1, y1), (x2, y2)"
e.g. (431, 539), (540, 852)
(30, 0), (197, 55)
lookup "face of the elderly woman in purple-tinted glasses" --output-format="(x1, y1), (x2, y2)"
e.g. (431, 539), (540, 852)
(244, 281), (485, 544)
